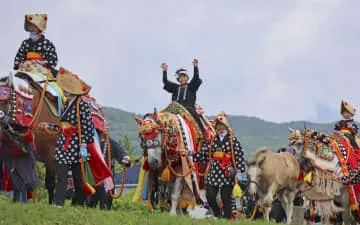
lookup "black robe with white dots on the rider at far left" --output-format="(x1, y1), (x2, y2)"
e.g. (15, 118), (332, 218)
(14, 36), (58, 74)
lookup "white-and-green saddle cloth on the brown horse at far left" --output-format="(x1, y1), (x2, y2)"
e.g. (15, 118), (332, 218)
(15, 70), (66, 117)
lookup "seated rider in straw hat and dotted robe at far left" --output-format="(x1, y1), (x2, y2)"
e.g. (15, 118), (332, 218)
(14, 14), (58, 77)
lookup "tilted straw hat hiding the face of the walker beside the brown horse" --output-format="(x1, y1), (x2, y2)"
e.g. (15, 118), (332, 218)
(56, 67), (91, 95)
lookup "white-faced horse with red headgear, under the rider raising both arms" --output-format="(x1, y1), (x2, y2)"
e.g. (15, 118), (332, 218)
(135, 110), (196, 215)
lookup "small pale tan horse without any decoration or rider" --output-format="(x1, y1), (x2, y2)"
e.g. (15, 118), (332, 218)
(247, 147), (300, 224)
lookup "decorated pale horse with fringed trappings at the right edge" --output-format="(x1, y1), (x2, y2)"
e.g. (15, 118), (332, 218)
(289, 129), (358, 224)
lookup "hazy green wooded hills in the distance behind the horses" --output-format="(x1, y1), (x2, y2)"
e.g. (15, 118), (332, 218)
(104, 107), (334, 157)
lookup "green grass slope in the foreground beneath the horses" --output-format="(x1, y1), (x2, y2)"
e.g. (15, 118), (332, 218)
(0, 193), (278, 225)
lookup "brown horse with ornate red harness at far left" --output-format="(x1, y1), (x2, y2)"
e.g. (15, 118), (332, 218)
(0, 72), (61, 204)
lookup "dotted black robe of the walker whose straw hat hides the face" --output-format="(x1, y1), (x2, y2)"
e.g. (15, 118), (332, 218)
(55, 97), (94, 164)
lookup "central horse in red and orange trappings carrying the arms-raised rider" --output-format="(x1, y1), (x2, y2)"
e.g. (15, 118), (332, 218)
(135, 102), (215, 215)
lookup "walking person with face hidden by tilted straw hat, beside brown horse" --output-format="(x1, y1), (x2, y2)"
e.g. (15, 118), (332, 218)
(54, 68), (112, 207)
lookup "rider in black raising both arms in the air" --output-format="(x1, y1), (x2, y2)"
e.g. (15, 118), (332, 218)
(161, 59), (208, 139)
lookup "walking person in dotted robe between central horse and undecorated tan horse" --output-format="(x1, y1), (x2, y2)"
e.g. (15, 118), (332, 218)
(194, 112), (245, 219)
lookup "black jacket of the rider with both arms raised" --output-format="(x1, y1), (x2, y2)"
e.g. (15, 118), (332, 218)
(163, 67), (202, 107)
